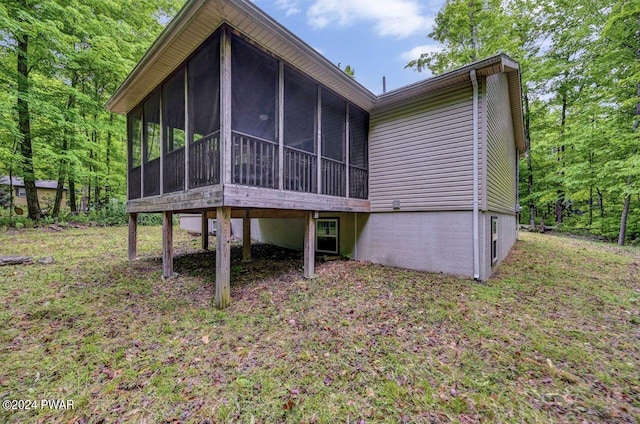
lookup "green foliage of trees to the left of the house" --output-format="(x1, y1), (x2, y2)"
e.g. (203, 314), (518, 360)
(0, 0), (184, 219)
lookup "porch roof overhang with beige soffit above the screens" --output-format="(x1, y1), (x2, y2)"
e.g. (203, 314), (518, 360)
(106, 0), (376, 114)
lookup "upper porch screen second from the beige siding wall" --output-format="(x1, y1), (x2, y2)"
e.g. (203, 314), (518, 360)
(321, 89), (347, 162)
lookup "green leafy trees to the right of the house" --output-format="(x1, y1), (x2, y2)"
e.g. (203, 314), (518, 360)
(407, 0), (640, 241)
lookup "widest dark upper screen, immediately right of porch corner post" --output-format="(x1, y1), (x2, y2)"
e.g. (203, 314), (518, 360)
(231, 37), (278, 141)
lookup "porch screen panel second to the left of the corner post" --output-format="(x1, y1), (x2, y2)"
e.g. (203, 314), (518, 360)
(162, 68), (185, 153)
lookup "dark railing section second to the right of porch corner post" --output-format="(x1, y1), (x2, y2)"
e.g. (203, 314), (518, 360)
(283, 147), (318, 193)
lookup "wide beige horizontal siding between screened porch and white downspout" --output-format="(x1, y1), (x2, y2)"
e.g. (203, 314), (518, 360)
(369, 83), (483, 212)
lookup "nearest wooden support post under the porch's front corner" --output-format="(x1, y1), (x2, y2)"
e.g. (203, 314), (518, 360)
(215, 206), (231, 309)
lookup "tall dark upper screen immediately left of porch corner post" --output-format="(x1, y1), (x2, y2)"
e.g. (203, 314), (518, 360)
(187, 35), (220, 142)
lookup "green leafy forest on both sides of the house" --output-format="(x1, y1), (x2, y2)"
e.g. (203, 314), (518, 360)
(0, 0), (640, 244)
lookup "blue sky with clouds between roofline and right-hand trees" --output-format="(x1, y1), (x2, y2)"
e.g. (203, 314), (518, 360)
(253, 0), (444, 94)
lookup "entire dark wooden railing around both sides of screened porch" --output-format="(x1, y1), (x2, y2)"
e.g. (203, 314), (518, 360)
(128, 131), (369, 199)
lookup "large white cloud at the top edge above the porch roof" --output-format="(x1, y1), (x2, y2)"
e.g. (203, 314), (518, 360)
(306, 0), (433, 38)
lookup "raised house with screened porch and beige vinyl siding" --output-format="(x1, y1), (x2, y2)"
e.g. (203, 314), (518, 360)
(106, 0), (524, 307)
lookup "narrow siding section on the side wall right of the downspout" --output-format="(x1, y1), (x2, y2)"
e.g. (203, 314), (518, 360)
(486, 74), (517, 214)
